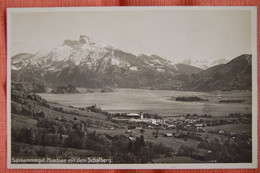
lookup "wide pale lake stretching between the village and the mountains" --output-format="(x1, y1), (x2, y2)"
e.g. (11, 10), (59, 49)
(39, 89), (252, 116)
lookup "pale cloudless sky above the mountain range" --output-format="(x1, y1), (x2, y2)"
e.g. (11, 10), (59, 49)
(7, 8), (252, 62)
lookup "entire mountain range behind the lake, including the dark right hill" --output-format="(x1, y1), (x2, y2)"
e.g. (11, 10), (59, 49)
(11, 35), (251, 91)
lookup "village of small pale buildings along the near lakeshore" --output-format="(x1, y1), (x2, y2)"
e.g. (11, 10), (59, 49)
(109, 112), (251, 137)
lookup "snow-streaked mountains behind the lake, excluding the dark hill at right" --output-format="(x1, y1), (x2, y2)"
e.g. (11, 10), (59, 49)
(11, 35), (250, 89)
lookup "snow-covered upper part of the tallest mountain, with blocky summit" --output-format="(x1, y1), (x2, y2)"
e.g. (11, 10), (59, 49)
(12, 35), (110, 71)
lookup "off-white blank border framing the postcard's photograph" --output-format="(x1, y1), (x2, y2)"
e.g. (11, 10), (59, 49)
(6, 6), (258, 169)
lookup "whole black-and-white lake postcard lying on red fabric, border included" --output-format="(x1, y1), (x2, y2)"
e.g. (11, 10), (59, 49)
(7, 7), (257, 169)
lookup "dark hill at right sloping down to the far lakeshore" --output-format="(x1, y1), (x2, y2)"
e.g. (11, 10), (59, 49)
(185, 54), (252, 91)
